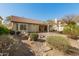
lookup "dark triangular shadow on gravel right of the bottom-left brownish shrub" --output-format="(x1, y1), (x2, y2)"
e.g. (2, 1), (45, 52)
(11, 43), (35, 56)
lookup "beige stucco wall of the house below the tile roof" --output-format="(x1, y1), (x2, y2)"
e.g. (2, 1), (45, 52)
(12, 23), (42, 32)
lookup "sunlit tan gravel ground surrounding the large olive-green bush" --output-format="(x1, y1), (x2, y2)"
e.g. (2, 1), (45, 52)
(22, 33), (79, 56)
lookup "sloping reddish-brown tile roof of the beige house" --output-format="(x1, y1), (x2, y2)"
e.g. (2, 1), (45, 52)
(11, 16), (47, 25)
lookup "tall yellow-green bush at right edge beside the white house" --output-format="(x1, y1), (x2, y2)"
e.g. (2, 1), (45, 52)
(63, 25), (79, 39)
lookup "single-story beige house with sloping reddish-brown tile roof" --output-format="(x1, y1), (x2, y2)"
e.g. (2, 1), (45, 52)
(8, 16), (48, 32)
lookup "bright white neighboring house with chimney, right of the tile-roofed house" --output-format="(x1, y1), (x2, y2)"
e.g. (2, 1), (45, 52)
(45, 18), (65, 32)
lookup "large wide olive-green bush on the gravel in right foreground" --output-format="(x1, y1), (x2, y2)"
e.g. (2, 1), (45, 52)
(46, 36), (70, 51)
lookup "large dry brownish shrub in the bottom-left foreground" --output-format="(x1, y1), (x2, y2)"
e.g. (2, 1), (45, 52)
(0, 35), (20, 56)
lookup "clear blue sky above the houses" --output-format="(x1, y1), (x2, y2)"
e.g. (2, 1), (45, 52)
(0, 3), (79, 21)
